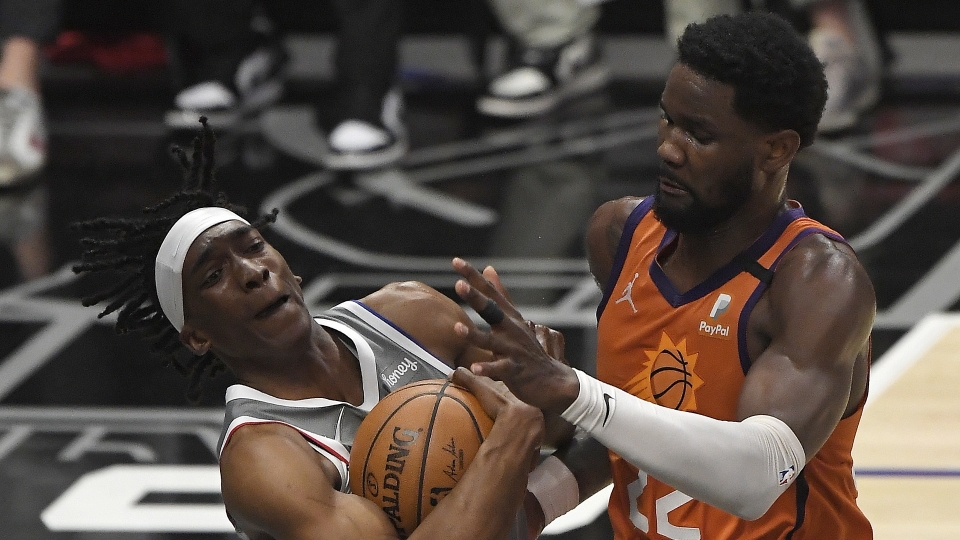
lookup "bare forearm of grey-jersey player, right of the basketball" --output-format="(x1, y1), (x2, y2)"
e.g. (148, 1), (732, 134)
(410, 407), (543, 540)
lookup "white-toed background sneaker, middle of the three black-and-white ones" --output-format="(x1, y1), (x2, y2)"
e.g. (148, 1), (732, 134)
(322, 89), (409, 170)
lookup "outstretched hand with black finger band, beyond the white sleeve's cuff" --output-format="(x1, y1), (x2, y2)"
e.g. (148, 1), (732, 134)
(453, 258), (580, 414)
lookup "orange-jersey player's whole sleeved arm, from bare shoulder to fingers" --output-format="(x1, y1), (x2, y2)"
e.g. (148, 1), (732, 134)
(457, 239), (875, 519)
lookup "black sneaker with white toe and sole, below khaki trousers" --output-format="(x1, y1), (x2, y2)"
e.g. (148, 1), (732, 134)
(477, 35), (610, 118)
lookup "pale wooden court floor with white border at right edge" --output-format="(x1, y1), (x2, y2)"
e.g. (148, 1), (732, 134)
(854, 313), (960, 540)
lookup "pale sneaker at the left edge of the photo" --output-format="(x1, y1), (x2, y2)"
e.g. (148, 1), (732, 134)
(0, 88), (47, 188)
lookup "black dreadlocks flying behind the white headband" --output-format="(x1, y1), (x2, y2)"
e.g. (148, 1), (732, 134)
(72, 117), (277, 402)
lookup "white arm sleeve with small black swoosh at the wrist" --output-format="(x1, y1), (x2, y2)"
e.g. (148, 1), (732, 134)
(562, 370), (805, 520)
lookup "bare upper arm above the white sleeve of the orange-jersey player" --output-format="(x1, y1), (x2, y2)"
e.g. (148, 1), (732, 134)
(738, 235), (876, 461)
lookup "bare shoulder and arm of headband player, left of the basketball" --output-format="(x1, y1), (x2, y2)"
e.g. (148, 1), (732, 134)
(220, 424), (396, 540)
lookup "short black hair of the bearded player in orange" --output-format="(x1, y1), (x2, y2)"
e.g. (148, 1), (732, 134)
(677, 11), (827, 148)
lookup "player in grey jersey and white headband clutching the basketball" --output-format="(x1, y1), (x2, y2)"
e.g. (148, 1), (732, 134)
(75, 118), (562, 540)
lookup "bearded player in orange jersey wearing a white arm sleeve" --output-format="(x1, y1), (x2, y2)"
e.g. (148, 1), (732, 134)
(454, 9), (876, 540)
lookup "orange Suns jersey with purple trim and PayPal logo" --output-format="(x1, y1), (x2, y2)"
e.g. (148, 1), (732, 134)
(597, 197), (872, 540)
